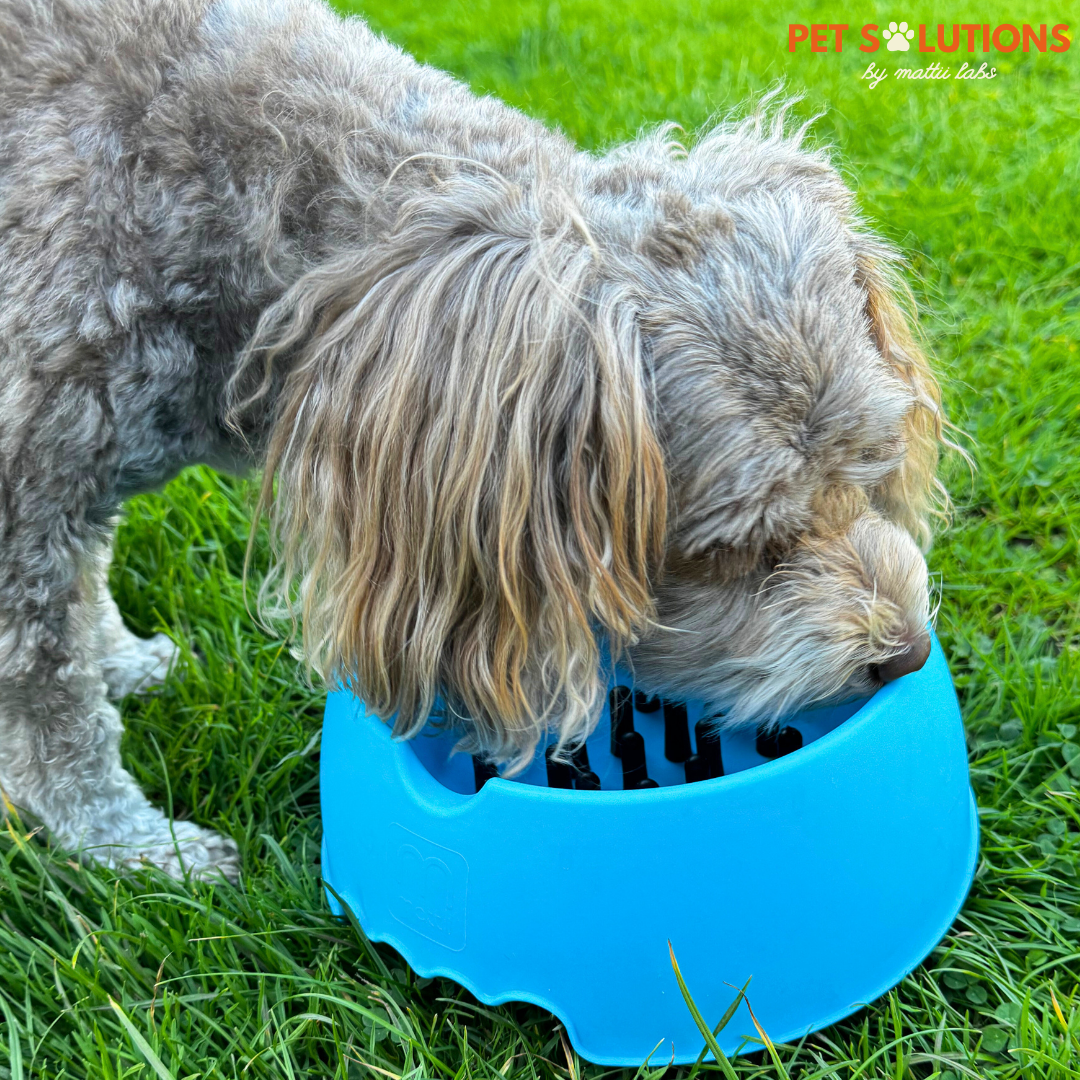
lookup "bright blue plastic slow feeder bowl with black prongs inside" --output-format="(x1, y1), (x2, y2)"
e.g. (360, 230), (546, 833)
(321, 639), (978, 1065)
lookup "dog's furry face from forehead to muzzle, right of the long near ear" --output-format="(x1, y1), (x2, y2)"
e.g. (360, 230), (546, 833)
(617, 146), (936, 723)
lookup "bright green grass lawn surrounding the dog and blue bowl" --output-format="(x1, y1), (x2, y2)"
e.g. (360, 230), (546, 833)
(0, 0), (1080, 1080)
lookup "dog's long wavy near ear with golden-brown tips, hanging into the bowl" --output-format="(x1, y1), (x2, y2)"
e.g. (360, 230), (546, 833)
(232, 178), (666, 765)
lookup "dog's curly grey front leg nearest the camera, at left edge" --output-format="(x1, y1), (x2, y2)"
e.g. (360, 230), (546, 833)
(0, 538), (238, 879)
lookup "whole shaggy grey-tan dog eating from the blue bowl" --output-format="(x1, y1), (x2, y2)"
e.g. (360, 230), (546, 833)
(0, 0), (942, 876)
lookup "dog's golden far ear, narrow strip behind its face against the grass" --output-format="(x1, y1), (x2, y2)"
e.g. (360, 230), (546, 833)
(856, 251), (948, 548)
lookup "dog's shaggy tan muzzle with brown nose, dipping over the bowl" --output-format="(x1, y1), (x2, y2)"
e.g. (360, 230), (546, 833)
(631, 488), (929, 723)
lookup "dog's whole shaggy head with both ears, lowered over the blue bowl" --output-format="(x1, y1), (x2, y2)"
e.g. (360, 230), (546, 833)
(238, 103), (941, 764)
